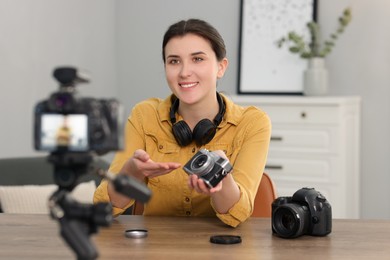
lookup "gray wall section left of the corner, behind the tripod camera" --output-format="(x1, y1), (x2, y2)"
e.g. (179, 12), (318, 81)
(0, 0), (118, 157)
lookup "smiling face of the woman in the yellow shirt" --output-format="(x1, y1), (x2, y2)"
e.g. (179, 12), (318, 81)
(165, 33), (228, 104)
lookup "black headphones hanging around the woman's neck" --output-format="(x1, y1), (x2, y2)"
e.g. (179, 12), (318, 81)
(169, 92), (225, 147)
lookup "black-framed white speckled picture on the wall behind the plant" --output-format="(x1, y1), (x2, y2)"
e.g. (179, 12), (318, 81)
(238, 0), (317, 95)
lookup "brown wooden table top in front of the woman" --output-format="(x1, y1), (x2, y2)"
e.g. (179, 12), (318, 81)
(0, 214), (390, 260)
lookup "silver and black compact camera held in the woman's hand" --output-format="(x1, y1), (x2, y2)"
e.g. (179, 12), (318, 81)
(183, 149), (233, 188)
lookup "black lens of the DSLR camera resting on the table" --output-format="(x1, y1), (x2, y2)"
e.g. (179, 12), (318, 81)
(272, 203), (310, 238)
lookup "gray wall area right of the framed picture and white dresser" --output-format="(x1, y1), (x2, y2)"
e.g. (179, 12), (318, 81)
(320, 0), (390, 218)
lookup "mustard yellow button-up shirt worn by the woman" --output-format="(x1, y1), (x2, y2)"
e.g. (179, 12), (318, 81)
(94, 96), (271, 227)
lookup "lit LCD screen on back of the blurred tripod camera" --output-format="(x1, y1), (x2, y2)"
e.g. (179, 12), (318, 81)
(40, 114), (89, 151)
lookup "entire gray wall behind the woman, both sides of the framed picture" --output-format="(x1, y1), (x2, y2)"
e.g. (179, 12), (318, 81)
(0, 0), (390, 218)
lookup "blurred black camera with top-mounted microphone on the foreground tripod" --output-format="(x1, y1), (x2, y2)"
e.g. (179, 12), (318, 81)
(34, 67), (123, 154)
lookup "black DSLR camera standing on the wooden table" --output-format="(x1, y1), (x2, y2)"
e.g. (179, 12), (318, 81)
(272, 188), (332, 238)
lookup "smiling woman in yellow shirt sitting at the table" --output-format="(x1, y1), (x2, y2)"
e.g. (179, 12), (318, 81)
(94, 19), (271, 227)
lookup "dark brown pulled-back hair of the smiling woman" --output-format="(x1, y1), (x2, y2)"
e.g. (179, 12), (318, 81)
(162, 19), (226, 63)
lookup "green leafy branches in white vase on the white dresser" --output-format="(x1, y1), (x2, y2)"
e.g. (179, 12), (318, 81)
(276, 8), (352, 95)
